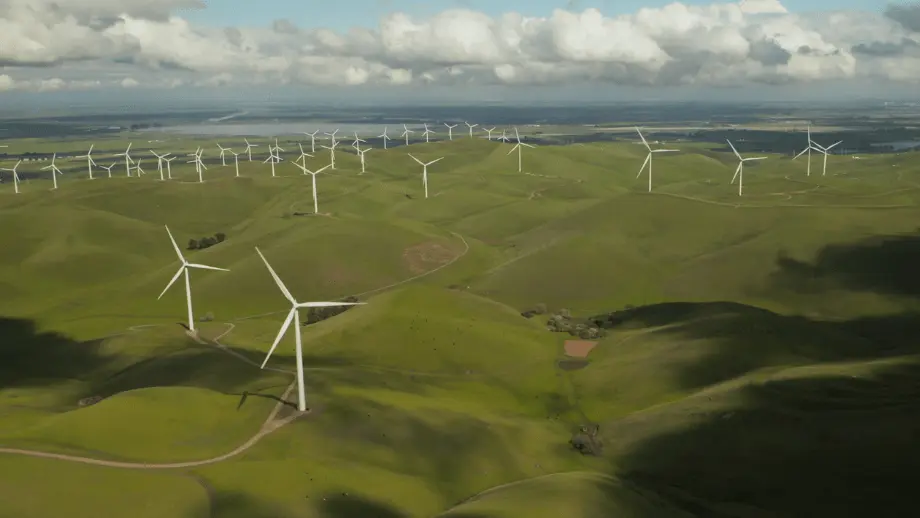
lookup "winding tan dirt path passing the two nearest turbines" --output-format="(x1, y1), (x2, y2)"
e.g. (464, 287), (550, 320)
(0, 232), (470, 469)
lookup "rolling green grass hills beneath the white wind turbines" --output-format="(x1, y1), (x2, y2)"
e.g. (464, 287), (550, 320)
(0, 135), (920, 518)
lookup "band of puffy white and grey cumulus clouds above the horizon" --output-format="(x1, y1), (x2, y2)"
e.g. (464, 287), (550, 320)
(0, 0), (920, 91)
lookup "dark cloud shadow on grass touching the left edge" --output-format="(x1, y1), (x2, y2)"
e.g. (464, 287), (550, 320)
(0, 317), (108, 388)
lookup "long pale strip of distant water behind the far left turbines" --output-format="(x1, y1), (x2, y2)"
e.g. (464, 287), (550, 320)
(143, 122), (428, 138)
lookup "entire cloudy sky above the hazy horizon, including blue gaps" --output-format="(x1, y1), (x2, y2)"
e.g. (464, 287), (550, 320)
(0, 0), (920, 106)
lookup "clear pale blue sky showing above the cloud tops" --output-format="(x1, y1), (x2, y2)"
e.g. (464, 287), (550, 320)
(183, 0), (888, 30)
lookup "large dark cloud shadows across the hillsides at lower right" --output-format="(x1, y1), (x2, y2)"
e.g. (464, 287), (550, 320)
(606, 236), (920, 517)
